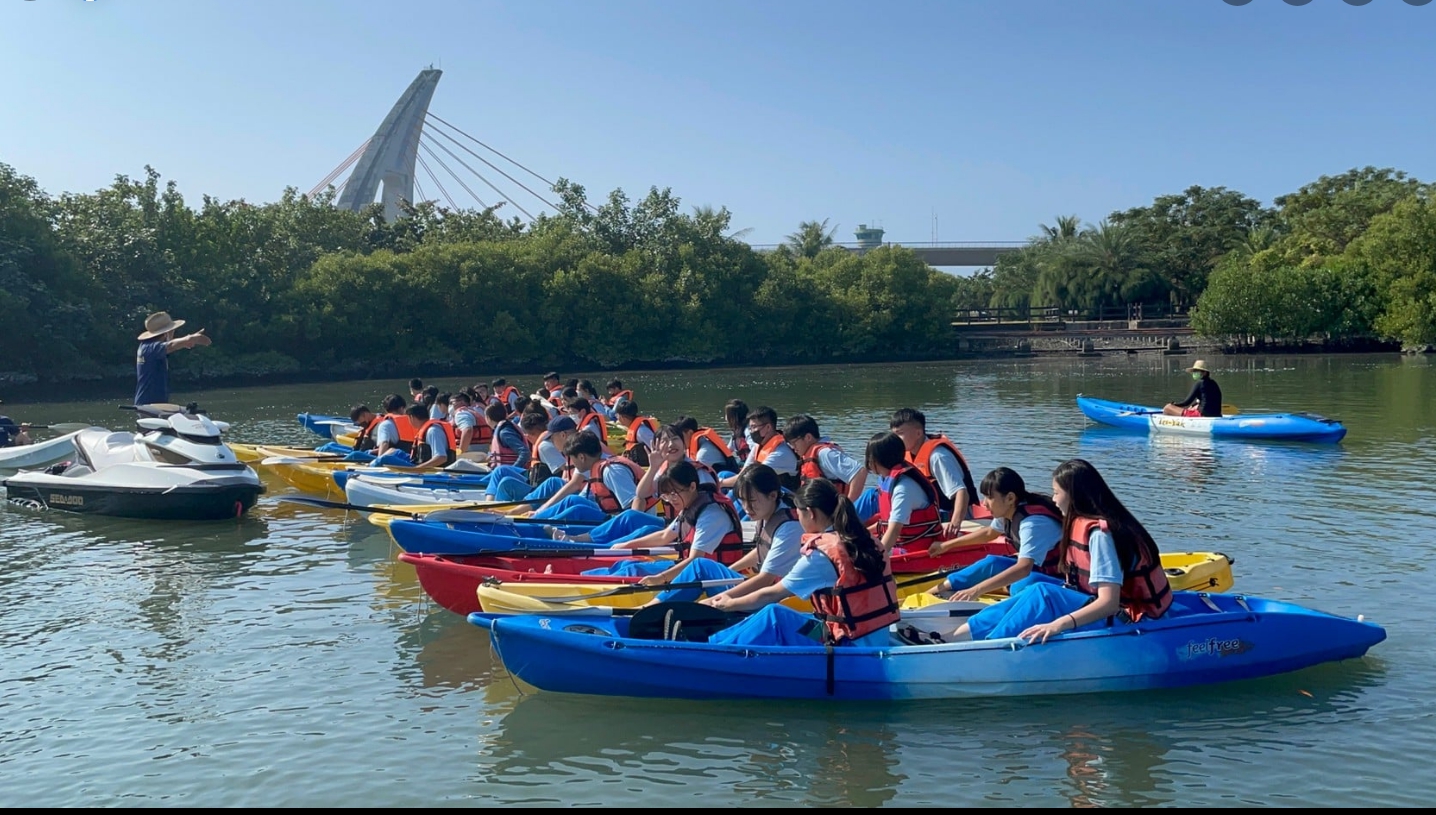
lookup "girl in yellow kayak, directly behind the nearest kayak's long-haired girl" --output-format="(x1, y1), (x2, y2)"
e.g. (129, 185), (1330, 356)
(928, 466), (1063, 600)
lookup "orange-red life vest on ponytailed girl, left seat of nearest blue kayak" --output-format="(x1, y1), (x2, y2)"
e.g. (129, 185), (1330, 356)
(803, 532), (902, 644)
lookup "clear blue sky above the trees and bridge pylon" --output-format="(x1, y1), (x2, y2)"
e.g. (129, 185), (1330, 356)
(0, 0), (1436, 251)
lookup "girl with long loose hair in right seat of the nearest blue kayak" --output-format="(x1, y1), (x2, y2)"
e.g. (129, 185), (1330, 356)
(956, 459), (1172, 643)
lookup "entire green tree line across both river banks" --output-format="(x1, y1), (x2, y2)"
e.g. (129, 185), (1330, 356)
(0, 164), (1436, 396)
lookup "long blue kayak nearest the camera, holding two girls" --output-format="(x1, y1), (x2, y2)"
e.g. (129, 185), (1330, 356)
(468, 591), (1386, 700)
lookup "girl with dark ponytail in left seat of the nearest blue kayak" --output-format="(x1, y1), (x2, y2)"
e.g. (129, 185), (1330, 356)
(709, 478), (899, 647)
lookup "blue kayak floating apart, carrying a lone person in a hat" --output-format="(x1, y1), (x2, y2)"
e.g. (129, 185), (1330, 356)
(1077, 393), (1346, 443)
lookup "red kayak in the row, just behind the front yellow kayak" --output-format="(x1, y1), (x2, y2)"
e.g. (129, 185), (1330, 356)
(399, 538), (1012, 614)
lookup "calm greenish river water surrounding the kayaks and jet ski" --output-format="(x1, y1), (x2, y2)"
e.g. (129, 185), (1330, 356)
(0, 356), (1436, 806)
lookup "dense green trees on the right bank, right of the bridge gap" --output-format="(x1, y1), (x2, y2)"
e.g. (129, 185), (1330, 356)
(958, 166), (1436, 347)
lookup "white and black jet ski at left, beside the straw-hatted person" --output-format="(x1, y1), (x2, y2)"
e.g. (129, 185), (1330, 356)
(0, 408), (264, 521)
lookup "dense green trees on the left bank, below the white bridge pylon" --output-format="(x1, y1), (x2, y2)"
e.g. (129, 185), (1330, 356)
(0, 165), (958, 385)
